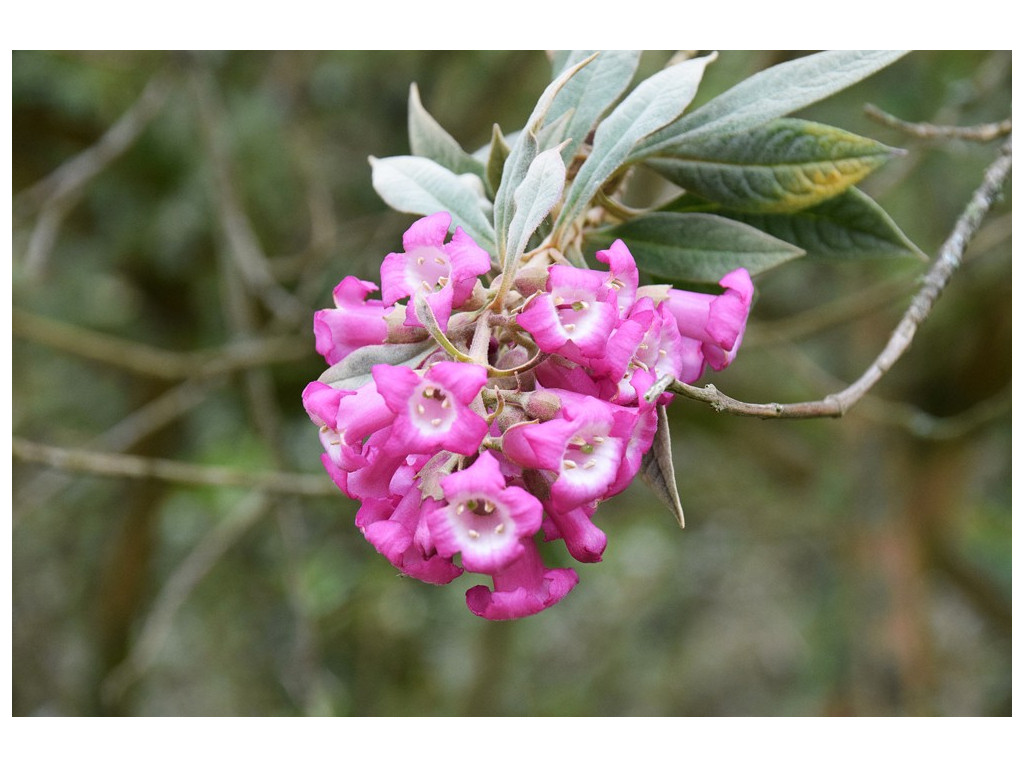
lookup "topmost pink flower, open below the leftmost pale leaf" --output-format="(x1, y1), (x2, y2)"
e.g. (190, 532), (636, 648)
(381, 211), (490, 332)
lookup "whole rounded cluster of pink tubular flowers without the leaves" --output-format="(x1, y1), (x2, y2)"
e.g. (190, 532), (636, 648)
(302, 212), (753, 620)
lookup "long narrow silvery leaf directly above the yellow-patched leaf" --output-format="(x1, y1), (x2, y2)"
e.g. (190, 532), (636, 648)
(633, 50), (906, 159)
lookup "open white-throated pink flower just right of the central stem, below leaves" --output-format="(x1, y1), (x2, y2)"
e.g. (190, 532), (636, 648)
(517, 264), (618, 365)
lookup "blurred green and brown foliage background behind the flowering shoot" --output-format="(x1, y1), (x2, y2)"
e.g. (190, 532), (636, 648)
(12, 51), (1011, 715)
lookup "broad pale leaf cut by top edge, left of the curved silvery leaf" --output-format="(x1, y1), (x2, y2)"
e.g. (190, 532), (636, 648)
(548, 50), (640, 163)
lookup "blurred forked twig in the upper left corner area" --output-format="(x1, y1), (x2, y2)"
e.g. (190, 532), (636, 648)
(14, 72), (173, 278)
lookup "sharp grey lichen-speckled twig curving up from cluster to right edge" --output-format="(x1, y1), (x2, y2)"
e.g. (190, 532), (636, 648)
(646, 139), (1013, 419)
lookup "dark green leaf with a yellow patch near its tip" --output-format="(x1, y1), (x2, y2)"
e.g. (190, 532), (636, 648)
(647, 118), (898, 213)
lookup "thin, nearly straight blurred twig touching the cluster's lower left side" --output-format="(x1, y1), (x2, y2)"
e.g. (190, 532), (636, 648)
(12, 437), (338, 496)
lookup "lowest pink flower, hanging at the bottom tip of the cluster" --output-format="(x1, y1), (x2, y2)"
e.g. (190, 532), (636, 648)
(466, 539), (580, 621)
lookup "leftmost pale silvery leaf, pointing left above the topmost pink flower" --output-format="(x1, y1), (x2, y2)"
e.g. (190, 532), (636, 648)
(370, 155), (495, 253)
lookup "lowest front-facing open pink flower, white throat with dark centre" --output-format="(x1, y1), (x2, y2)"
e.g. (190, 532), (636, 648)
(427, 452), (543, 573)
